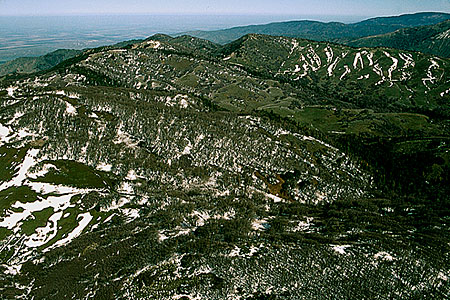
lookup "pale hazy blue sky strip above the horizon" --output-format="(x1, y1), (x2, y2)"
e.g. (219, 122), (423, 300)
(0, 0), (450, 16)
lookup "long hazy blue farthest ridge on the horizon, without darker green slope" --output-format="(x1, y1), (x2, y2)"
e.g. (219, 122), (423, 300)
(183, 13), (450, 44)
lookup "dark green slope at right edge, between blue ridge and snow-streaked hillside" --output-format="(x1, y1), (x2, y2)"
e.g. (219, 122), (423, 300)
(349, 21), (450, 57)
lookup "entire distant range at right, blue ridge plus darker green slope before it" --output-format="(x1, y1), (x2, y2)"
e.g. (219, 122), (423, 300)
(187, 12), (450, 56)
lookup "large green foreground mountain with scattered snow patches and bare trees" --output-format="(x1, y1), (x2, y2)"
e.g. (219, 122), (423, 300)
(0, 35), (450, 299)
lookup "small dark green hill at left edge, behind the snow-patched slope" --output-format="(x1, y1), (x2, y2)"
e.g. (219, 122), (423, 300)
(0, 49), (82, 76)
